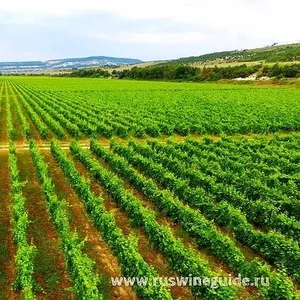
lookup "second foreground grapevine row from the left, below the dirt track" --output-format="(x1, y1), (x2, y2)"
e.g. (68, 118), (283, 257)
(29, 140), (103, 300)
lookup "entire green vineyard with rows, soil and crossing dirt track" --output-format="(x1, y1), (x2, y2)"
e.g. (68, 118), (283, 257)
(0, 76), (300, 300)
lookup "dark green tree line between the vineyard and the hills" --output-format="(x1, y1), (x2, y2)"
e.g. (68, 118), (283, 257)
(0, 63), (300, 82)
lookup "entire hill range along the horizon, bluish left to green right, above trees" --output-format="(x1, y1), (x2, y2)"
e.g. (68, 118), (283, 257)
(0, 43), (300, 74)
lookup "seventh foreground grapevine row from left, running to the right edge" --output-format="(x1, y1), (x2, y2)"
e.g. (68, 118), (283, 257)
(129, 142), (300, 241)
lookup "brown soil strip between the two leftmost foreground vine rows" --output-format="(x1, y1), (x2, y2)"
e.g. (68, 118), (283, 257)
(17, 151), (73, 299)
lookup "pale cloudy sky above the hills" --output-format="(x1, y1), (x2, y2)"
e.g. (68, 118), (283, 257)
(0, 0), (300, 62)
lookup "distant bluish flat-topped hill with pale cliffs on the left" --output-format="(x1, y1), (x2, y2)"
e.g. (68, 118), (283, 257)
(0, 56), (142, 73)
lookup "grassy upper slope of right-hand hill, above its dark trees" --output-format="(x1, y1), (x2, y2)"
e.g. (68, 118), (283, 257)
(167, 43), (300, 64)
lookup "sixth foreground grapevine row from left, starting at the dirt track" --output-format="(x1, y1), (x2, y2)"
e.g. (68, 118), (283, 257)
(112, 143), (300, 280)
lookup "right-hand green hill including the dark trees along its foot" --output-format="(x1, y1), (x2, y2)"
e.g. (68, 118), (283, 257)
(112, 43), (300, 82)
